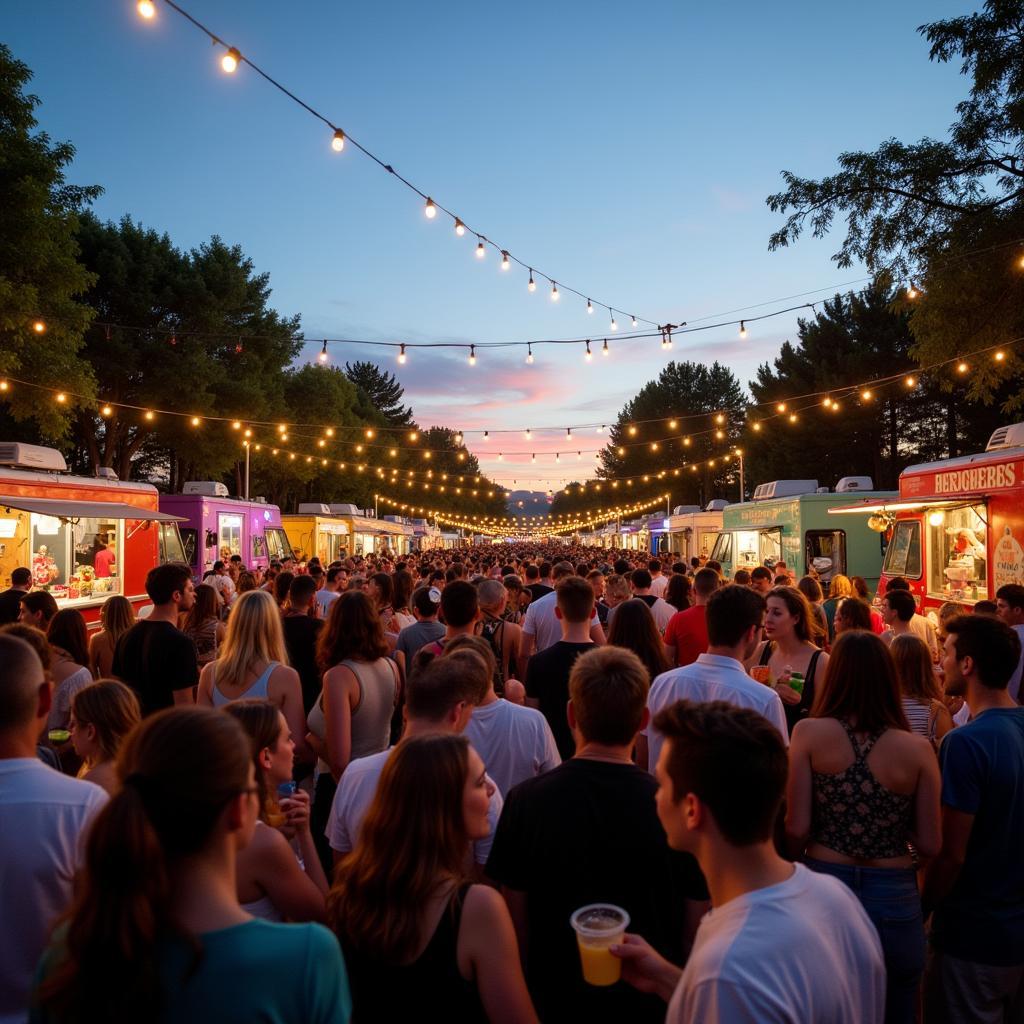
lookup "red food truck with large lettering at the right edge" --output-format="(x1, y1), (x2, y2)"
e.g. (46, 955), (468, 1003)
(831, 423), (1024, 613)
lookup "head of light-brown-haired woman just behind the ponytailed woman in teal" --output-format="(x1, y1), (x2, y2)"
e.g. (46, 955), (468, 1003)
(71, 679), (142, 794)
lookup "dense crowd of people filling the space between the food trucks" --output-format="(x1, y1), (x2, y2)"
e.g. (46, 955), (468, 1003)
(0, 541), (1024, 1024)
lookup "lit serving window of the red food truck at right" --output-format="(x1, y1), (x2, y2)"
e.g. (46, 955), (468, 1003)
(926, 505), (988, 601)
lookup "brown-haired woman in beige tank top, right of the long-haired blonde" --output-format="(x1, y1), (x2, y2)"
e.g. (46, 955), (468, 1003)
(306, 590), (399, 870)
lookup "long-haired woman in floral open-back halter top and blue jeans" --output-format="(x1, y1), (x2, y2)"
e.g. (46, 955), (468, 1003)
(785, 630), (942, 1024)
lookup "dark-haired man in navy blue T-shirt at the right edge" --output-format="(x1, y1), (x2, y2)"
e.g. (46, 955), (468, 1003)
(921, 610), (1024, 1024)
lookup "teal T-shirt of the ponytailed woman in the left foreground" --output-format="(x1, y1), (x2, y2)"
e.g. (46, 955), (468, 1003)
(29, 919), (352, 1024)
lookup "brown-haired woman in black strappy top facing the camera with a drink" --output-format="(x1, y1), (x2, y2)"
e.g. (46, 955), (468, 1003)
(748, 587), (828, 732)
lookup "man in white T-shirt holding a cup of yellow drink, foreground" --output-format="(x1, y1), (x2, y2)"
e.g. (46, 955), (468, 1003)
(611, 700), (886, 1024)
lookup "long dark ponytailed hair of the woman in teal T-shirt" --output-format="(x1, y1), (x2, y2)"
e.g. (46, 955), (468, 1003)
(38, 708), (252, 1024)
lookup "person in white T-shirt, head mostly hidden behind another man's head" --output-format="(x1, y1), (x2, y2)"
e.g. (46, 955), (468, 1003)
(458, 637), (562, 794)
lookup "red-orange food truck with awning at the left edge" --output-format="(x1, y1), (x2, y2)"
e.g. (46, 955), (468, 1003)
(0, 442), (184, 624)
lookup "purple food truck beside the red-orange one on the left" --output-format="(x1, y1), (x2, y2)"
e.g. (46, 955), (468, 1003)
(160, 480), (293, 579)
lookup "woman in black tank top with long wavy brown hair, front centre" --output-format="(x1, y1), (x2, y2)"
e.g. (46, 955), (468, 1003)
(328, 735), (537, 1024)
